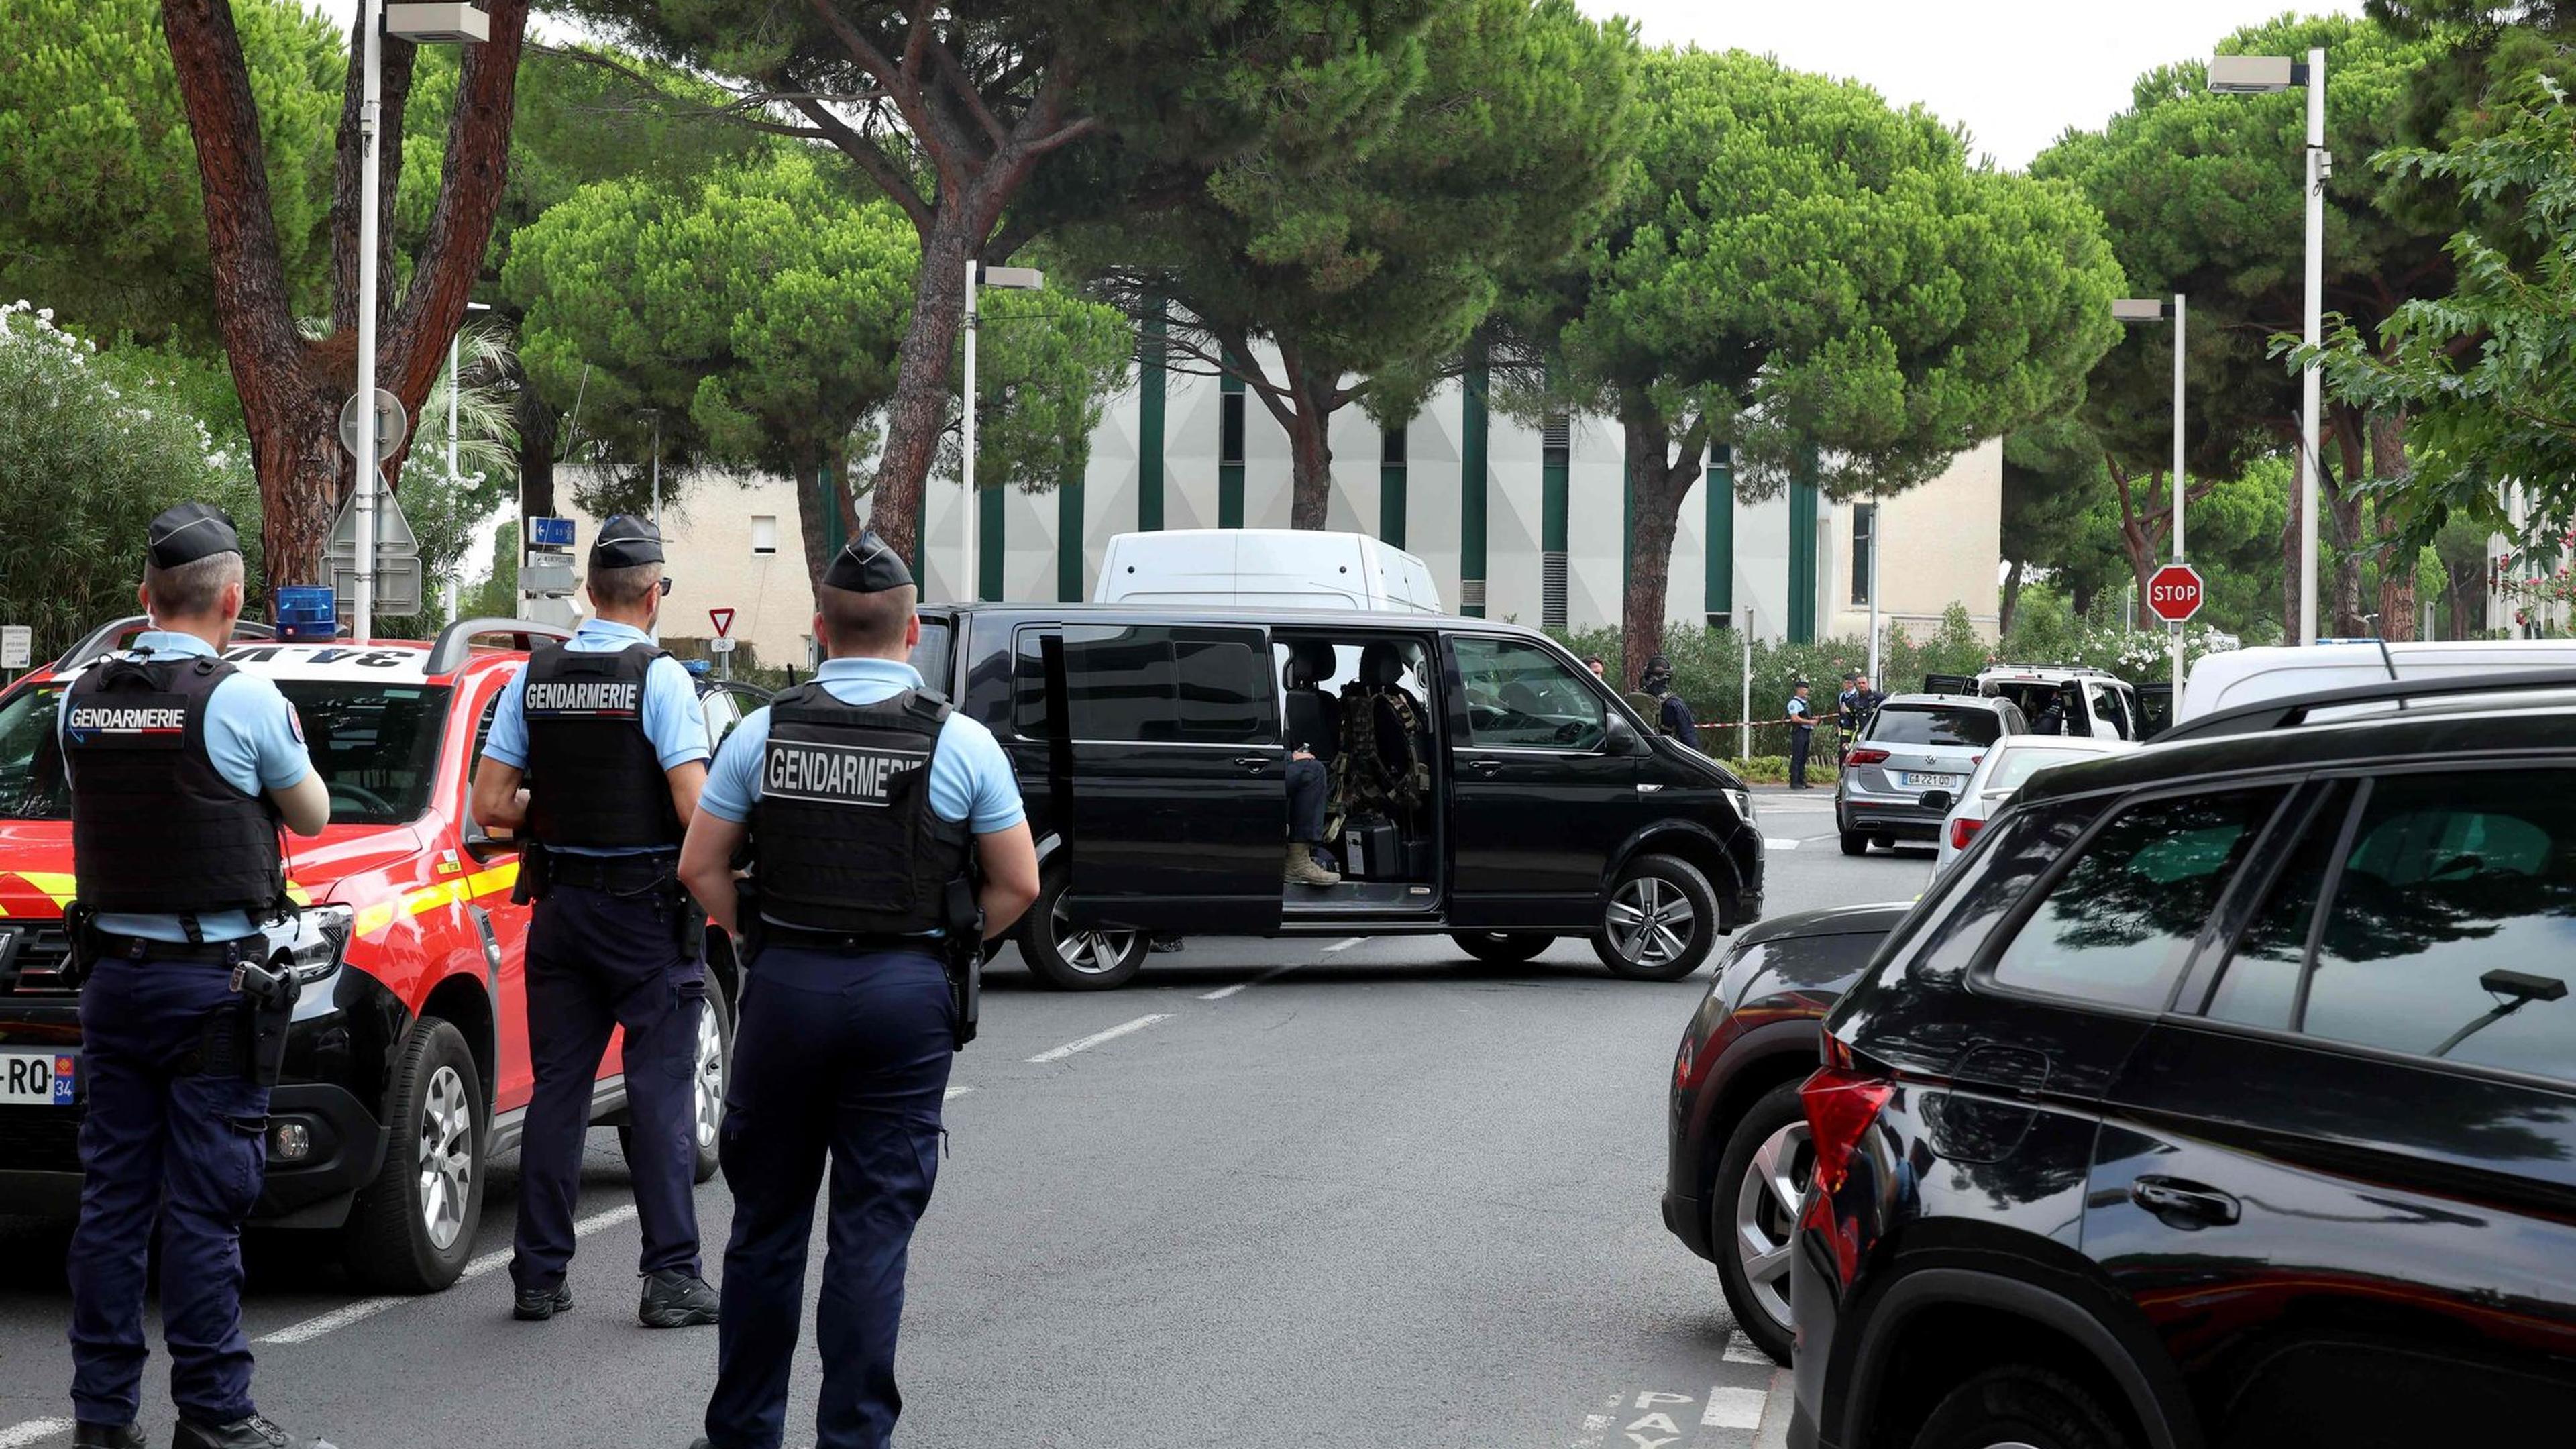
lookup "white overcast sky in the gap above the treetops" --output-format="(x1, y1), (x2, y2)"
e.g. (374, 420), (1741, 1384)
(1582, 0), (2362, 168)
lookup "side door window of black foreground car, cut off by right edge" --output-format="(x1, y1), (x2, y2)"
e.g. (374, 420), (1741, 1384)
(2298, 768), (2576, 1080)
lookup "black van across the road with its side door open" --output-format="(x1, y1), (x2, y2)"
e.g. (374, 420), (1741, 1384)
(912, 603), (1762, 990)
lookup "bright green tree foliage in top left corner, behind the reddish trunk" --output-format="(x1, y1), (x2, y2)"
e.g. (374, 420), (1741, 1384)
(0, 0), (347, 351)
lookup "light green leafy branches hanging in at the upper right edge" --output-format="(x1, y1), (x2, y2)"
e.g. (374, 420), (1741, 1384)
(2321, 83), (2576, 541)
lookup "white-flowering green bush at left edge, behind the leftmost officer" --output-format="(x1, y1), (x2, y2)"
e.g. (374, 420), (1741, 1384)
(0, 302), (260, 655)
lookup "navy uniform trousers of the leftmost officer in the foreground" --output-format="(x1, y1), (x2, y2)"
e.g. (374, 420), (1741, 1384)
(72, 959), (268, 1424)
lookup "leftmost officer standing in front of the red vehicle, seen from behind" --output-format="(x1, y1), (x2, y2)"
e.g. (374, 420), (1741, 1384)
(62, 502), (330, 1449)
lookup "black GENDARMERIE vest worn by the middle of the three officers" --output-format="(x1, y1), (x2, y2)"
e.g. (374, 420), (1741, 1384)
(521, 645), (680, 851)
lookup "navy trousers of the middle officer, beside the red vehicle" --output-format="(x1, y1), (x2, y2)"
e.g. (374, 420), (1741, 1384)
(510, 884), (706, 1292)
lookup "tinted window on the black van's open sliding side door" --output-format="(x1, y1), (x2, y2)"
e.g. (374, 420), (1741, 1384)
(1061, 627), (1275, 743)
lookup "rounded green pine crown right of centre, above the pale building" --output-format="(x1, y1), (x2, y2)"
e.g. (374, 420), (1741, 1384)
(1536, 49), (2120, 495)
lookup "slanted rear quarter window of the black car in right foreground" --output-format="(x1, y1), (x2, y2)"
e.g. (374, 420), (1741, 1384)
(1994, 789), (2282, 1011)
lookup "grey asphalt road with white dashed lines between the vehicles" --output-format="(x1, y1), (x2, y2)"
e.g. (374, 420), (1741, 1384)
(0, 792), (1932, 1449)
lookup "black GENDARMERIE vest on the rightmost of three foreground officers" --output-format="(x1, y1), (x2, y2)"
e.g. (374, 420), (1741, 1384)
(752, 684), (974, 936)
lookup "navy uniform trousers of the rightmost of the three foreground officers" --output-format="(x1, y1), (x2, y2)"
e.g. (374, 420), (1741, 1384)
(706, 947), (956, 1449)
